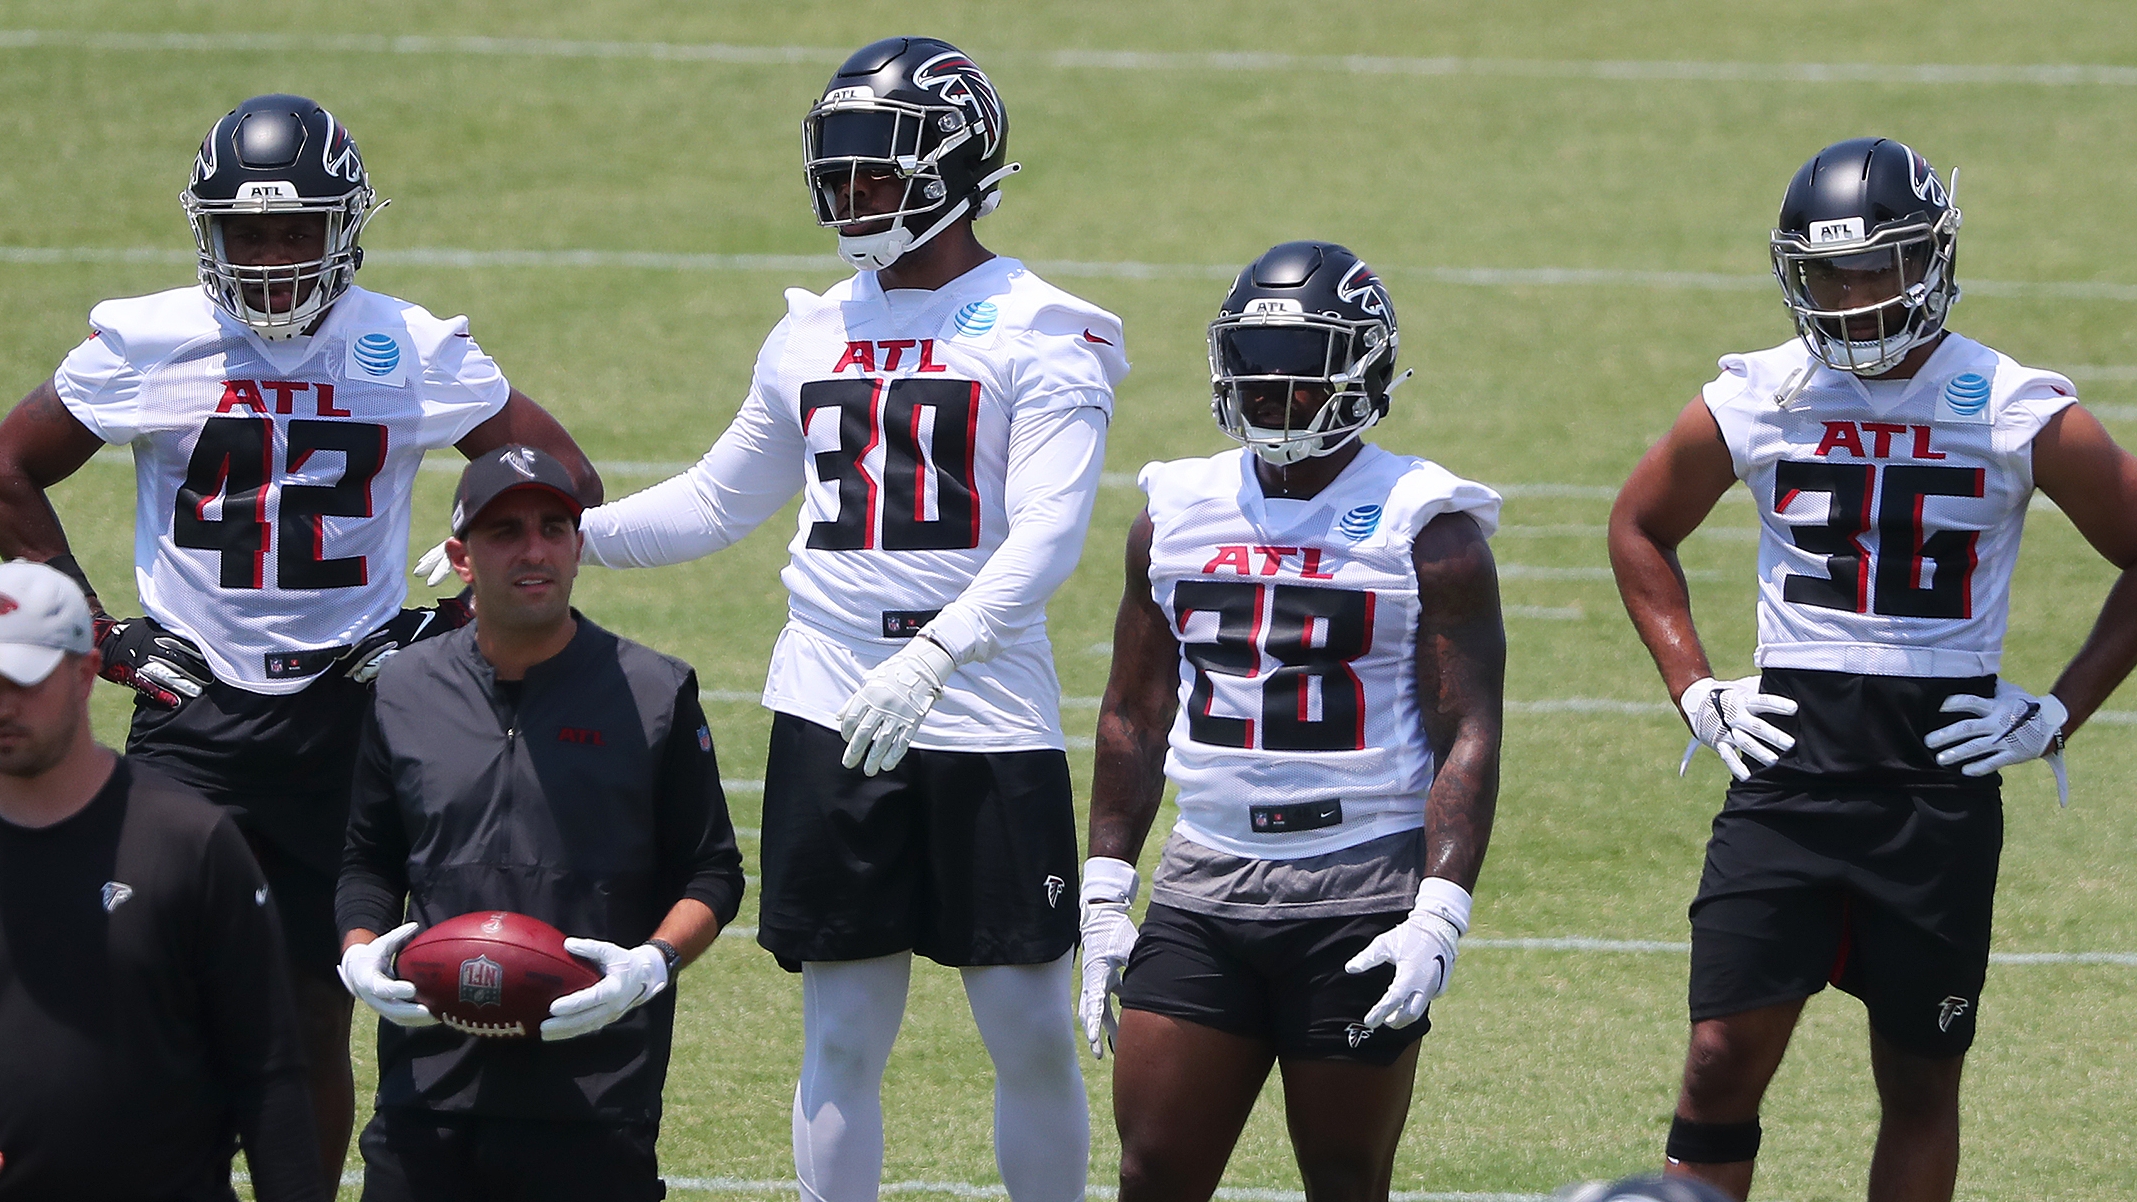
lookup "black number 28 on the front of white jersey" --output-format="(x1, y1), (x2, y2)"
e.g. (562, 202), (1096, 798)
(1173, 580), (1372, 751)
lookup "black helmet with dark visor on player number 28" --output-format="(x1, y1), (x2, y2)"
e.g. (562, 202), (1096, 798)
(1210, 242), (1408, 466)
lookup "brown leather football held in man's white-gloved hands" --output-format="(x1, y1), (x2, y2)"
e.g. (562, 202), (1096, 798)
(393, 909), (600, 1037)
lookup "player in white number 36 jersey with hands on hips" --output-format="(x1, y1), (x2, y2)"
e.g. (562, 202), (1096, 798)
(1609, 137), (2137, 1200)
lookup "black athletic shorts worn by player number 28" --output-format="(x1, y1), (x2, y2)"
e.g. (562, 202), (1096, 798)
(1120, 905), (1432, 1067)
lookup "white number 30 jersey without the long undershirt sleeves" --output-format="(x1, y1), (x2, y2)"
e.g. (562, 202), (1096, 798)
(752, 259), (1128, 751)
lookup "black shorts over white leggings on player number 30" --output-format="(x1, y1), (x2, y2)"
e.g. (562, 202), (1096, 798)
(756, 714), (1077, 971)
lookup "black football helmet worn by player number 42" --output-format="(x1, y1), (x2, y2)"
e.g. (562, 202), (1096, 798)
(180, 94), (385, 338)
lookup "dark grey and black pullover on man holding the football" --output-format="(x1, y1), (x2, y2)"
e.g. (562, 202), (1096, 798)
(336, 616), (742, 1121)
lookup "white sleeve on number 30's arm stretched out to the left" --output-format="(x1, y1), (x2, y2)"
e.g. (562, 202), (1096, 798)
(579, 387), (808, 567)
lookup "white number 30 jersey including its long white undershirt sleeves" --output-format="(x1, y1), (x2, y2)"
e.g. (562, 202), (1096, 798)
(583, 259), (1128, 751)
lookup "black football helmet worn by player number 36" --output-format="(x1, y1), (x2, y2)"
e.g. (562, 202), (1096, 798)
(1774, 137), (1960, 376)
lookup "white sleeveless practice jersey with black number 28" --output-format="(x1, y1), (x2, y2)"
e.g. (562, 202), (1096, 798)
(1141, 445), (1500, 860)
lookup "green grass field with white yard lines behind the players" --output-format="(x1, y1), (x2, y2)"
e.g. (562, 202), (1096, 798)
(0, 0), (2137, 1202)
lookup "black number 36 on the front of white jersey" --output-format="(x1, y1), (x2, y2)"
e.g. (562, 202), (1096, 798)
(1774, 460), (1985, 618)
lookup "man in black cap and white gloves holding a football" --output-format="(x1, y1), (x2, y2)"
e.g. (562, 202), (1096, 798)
(336, 447), (742, 1202)
